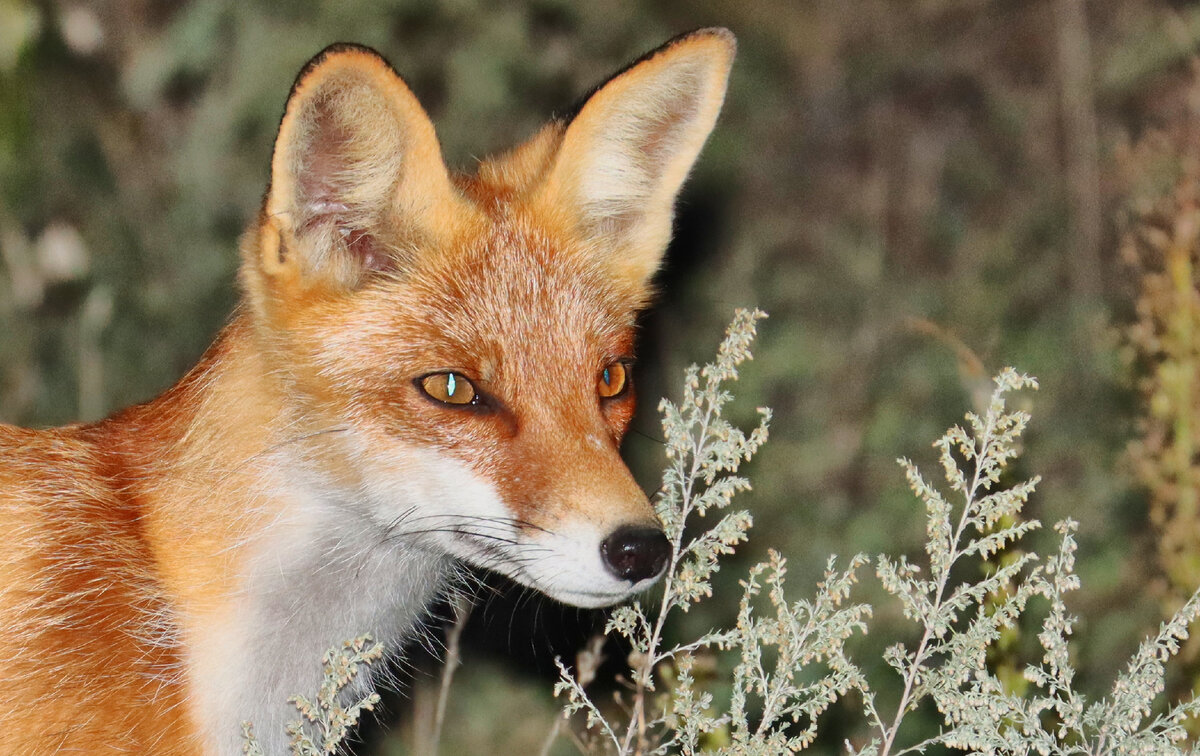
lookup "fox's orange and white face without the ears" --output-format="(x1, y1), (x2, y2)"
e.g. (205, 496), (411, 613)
(283, 218), (667, 606)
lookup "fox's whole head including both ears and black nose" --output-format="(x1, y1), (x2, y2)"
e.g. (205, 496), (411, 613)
(241, 29), (734, 606)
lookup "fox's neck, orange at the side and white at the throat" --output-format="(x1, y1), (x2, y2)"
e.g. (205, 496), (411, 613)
(92, 316), (450, 754)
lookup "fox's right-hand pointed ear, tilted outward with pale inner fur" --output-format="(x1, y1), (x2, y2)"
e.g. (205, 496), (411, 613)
(539, 29), (737, 286)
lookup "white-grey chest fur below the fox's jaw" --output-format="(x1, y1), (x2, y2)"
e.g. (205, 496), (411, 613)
(188, 475), (451, 756)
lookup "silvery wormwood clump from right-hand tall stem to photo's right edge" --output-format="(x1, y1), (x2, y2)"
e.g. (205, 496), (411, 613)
(847, 368), (1200, 756)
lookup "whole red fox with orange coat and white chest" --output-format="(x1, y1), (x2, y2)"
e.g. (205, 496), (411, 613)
(0, 29), (736, 756)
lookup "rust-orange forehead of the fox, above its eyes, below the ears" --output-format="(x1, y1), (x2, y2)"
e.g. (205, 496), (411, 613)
(314, 210), (647, 390)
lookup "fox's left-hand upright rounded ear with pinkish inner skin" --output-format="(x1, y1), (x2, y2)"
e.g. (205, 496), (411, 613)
(258, 44), (461, 287)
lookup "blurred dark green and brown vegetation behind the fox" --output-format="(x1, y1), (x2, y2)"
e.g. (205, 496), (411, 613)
(0, 0), (1200, 754)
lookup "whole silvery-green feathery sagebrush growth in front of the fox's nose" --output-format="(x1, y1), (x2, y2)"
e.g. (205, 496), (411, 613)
(554, 311), (1200, 756)
